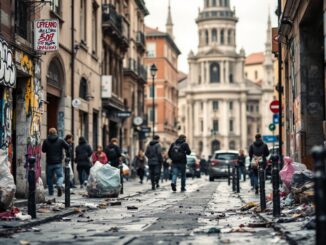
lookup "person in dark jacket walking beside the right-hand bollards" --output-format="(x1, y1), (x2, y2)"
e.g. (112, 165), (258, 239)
(249, 134), (269, 194)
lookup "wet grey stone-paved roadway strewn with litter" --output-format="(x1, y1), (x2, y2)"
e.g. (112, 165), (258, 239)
(0, 177), (287, 245)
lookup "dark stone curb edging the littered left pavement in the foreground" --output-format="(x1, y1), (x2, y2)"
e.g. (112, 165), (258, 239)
(0, 209), (87, 237)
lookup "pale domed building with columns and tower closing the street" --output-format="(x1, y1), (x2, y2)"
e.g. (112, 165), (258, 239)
(179, 0), (273, 157)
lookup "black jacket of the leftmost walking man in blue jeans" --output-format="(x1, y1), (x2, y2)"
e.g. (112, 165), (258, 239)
(42, 135), (70, 165)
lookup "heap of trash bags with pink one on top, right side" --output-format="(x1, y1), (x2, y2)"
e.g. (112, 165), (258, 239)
(280, 156), (314, 205)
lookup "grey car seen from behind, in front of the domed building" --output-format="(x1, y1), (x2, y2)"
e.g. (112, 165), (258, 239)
(208, 150), (239, 181)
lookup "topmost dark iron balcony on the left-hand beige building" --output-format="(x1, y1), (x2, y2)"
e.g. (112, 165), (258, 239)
(102, 4), (129, 52)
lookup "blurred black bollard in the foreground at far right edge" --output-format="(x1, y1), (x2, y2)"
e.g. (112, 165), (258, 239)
(312, 146), (326, 245)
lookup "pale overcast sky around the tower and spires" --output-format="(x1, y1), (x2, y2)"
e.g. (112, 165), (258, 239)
(145, 0), (277, 72)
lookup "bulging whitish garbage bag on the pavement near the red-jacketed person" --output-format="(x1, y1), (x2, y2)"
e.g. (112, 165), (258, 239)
(87, 162), (121, 197)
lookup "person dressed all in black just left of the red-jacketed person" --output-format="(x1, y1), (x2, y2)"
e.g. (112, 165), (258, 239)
(75, 136), (93, 188)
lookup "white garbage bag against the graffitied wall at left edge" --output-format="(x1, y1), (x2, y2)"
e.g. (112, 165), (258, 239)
(0, 150), (16, 211)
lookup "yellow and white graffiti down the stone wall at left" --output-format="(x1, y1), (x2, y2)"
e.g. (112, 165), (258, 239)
(19, 53), (43, 179)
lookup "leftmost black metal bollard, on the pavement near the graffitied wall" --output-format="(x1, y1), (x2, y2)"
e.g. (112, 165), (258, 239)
(27, 156), (36, 219)
